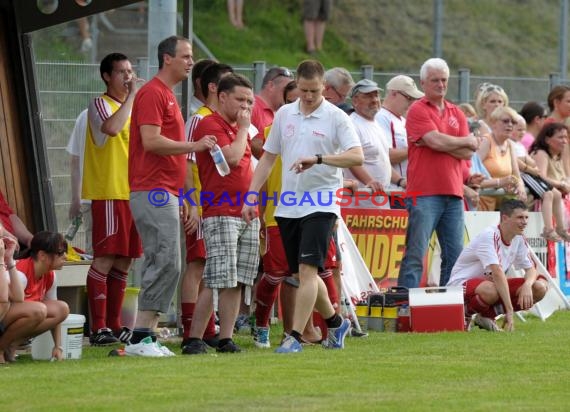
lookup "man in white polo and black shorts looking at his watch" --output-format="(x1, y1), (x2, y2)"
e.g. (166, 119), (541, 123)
(242, 60), (363, 353)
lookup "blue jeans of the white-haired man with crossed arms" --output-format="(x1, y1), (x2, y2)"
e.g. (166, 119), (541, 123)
(398, 196), (464, 288)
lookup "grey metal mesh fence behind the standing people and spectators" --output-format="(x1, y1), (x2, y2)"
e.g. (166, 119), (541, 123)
(36, 60), (558, 247)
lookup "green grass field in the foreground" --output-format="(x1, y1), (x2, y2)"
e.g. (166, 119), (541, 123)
(0, 312), (570, 412)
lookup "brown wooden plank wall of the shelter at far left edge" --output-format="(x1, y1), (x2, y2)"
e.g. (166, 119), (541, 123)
(0, 12), (34, 233)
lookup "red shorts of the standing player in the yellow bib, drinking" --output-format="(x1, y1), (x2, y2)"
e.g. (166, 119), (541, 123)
(91, 200), (142, 258)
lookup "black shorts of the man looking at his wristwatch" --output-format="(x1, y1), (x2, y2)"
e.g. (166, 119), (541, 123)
(275, 212), (337, 273)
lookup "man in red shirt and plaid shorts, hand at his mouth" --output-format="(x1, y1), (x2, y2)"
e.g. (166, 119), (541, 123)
(184, 73), (259, 355)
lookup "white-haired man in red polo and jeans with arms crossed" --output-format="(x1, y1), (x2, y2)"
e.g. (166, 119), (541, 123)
(398, 58), (480, 288)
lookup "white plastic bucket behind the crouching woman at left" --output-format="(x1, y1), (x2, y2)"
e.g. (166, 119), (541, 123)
(32, 314), (85, 360)
